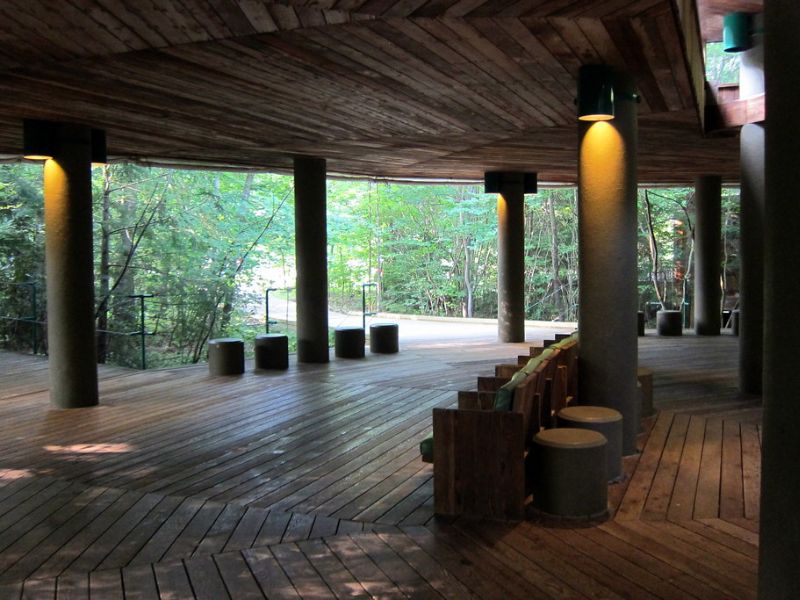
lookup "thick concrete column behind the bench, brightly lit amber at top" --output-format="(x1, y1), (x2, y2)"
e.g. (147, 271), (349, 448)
(578, 73), (639, 455)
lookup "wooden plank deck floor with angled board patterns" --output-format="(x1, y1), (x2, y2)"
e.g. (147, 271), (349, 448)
(0, 336), (760, 599)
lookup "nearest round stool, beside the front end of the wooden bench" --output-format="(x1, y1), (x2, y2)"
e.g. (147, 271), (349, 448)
(530, 427), (608, 519)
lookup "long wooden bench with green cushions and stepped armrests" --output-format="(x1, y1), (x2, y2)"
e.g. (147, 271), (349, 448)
(428, 337), (577, 520)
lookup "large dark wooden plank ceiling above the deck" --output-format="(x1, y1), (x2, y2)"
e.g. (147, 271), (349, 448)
(0, 0), (752, 183)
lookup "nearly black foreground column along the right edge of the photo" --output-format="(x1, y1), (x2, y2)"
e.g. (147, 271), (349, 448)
(758, 0), (800, 599)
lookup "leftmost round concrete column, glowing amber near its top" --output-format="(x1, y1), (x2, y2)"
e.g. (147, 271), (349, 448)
(44, 125), (99, 408)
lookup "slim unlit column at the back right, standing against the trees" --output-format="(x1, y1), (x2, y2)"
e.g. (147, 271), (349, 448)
(693, 175), (722, 335)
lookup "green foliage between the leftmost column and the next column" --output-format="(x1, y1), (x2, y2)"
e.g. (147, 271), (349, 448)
(96, 165), (293, 364)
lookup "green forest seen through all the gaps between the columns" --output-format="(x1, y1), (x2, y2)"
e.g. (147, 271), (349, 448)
(0, 163), (739, 366)
